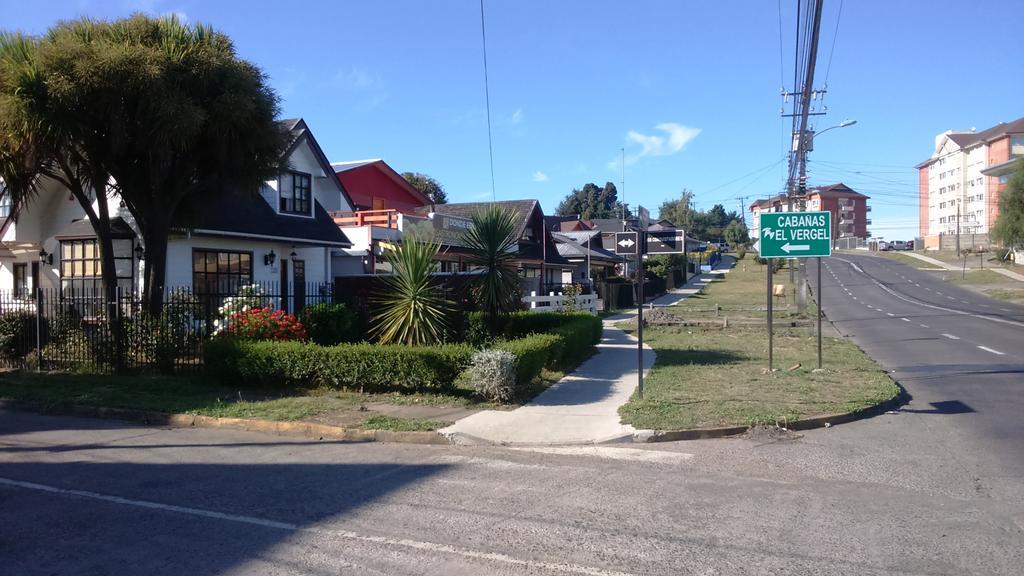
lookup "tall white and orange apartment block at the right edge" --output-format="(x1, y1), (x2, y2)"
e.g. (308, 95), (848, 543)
(914, 118), (1024, 241)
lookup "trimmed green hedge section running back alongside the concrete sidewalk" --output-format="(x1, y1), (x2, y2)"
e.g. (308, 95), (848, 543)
(495, 313), (602, 385)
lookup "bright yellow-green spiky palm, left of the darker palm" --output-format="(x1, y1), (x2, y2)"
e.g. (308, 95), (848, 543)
(371, 236), (454, 345)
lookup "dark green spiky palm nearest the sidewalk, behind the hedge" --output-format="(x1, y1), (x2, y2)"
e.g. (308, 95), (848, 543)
(463, 206), (519, 333)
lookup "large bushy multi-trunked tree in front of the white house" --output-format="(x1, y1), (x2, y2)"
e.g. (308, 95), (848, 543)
(0, 14), (288, 314)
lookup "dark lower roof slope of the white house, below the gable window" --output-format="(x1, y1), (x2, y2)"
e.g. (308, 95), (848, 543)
(191, 186), (351, 246)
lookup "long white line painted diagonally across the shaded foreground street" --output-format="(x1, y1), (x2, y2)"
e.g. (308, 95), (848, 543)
(0, 478), (631, 576)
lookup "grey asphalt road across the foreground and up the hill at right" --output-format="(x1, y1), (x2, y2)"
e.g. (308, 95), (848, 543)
(0, 256), (1024, 576)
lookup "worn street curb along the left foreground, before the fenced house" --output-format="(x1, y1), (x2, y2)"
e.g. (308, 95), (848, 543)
(0, 401), (450, 445)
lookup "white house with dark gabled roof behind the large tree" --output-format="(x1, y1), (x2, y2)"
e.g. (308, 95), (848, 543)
(0, 119), (352, 305)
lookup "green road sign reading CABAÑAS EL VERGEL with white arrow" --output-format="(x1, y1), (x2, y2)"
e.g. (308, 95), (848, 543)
(758, 212), (831, 258)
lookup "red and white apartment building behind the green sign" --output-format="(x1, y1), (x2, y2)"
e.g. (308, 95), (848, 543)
(751, 182), (871, 240)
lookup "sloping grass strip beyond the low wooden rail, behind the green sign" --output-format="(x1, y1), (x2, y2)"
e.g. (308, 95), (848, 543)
(666, 257), (814, 319)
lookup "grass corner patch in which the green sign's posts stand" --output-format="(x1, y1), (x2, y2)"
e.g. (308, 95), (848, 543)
(620, 327), (899, 429)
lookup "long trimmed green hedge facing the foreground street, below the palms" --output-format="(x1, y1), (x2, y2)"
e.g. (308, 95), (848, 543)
(204, 338), (473, 393)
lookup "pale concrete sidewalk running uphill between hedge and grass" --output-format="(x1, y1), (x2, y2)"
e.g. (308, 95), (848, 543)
(439, 262), (728, 445)
